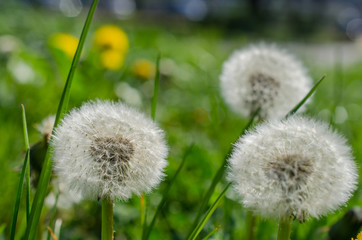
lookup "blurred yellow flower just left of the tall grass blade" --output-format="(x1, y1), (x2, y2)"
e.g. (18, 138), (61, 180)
(49, 33), (78, 58)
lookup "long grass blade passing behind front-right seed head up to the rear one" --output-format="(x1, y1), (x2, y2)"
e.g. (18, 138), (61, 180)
(188, 108), (260, 236)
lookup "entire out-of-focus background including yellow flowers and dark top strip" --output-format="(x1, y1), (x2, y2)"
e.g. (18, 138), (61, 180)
(0, 0), (362, 239)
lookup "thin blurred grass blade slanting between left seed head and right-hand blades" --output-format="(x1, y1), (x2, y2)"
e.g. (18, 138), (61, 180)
(142, 144), (194, 240)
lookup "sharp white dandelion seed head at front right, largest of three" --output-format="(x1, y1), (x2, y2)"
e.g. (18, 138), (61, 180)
(228, 116), (358, 222)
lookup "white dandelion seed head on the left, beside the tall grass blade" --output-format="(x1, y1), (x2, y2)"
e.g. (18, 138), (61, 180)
(51, 101), (168, 200)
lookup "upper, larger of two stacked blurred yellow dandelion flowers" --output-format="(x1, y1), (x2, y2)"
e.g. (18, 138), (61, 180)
(94, 25), (129, 54)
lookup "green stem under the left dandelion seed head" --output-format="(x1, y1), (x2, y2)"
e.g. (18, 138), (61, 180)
(102, 198), (113, 240)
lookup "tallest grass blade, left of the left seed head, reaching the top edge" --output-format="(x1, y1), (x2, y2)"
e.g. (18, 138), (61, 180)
(25, 0), (99, 239)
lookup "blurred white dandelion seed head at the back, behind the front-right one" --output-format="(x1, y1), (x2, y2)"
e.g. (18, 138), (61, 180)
(220, 44), (312, 119)
